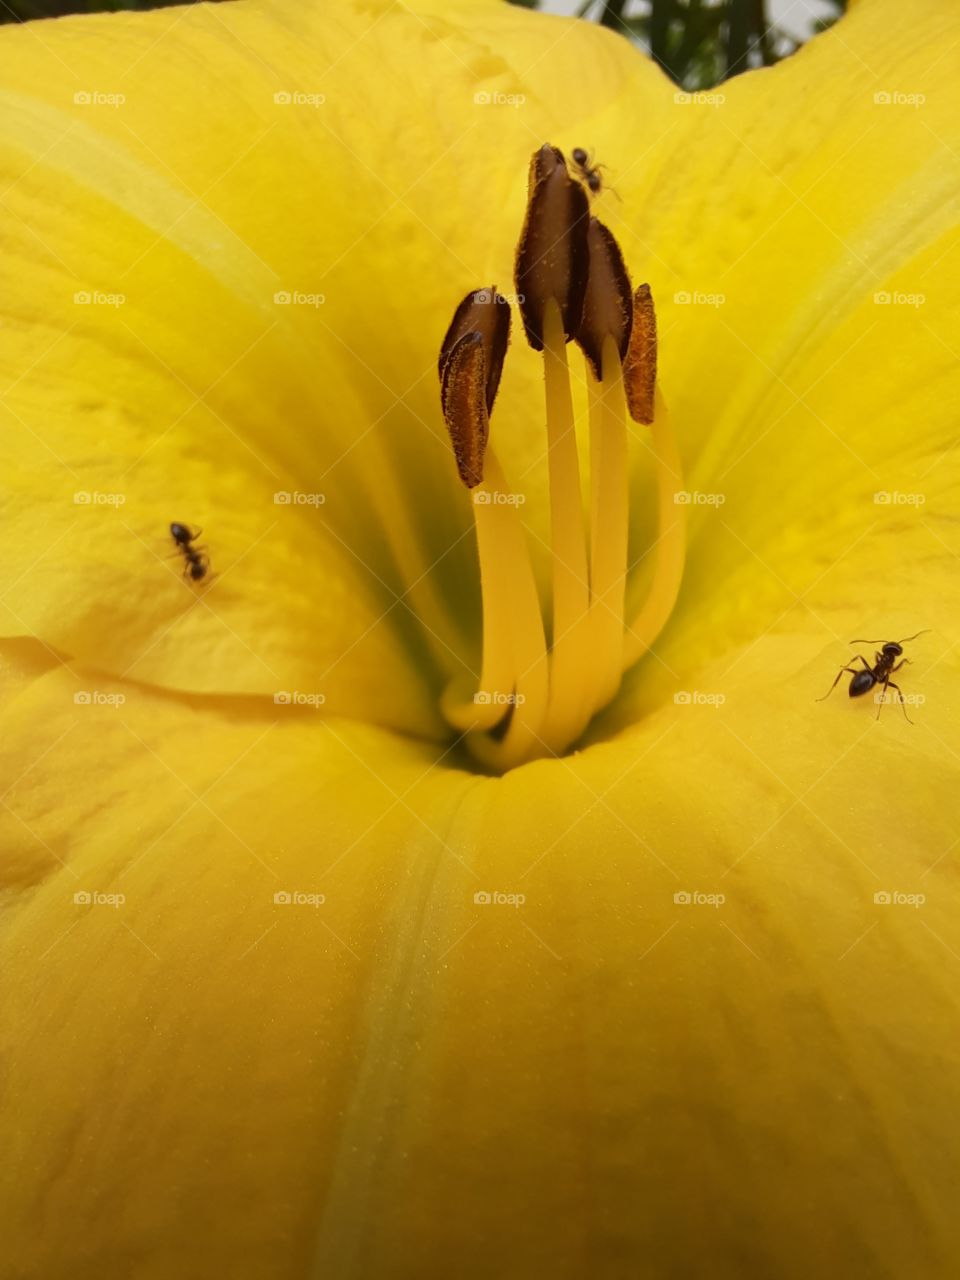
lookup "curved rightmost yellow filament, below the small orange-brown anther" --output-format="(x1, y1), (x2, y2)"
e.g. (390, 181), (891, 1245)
(623, 388), (686, 669)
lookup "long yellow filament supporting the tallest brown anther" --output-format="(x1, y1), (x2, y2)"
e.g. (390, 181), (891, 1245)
(543, 300), (590, 750)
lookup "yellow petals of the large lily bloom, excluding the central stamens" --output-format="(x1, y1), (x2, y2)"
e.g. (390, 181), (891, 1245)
(0, 0), (960, 1280)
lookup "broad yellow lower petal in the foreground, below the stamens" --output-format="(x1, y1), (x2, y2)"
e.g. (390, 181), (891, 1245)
(0, 640), (960, 1276)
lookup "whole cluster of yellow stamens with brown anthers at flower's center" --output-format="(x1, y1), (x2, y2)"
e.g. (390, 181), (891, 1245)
(439, 145), (684, 772)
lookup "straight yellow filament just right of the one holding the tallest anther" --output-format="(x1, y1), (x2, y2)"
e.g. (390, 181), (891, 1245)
(581, 338), (630, 714)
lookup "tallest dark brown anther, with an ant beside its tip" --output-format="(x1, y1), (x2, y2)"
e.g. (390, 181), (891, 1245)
(515, 143), (590, 351)
